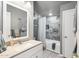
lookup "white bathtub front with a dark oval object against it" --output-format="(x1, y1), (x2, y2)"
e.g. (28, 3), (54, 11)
(46, 39), (60, 53)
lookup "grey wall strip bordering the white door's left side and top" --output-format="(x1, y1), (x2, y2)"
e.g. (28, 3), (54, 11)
(60, 1), (77, 53)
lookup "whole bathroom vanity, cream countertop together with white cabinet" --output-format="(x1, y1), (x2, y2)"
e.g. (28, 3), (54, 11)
(0, 40), (43, 58)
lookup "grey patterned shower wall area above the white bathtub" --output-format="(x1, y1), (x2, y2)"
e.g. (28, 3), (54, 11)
(46, 16), (60, 41)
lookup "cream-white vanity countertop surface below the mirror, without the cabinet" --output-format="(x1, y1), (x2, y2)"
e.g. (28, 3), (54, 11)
(0, 40), (41, 58)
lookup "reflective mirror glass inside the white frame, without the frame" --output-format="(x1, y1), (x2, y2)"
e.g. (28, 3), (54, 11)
(6, 4), (27, 38)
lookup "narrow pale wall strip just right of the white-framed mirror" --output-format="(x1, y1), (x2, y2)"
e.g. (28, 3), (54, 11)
(28, 2), (34, 39)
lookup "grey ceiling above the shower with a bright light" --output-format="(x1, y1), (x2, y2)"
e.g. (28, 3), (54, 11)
(34, 1), (74, 16)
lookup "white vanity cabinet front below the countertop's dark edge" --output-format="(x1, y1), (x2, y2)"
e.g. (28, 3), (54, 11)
(14, 44), (43, 58)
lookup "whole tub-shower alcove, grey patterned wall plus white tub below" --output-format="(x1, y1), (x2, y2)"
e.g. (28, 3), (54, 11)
(46, 16), (60, 53)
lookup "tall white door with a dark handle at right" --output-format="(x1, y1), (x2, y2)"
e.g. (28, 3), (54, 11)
(62, 9), (76, 57)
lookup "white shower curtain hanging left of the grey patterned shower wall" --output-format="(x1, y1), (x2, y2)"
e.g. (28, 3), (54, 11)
(38, 17), (46, 46)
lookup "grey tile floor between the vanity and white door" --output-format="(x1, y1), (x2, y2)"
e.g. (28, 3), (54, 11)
(43, 50), (63, 58)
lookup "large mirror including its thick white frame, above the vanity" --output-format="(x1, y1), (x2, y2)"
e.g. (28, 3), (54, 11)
(3, 2), (28, 39)
